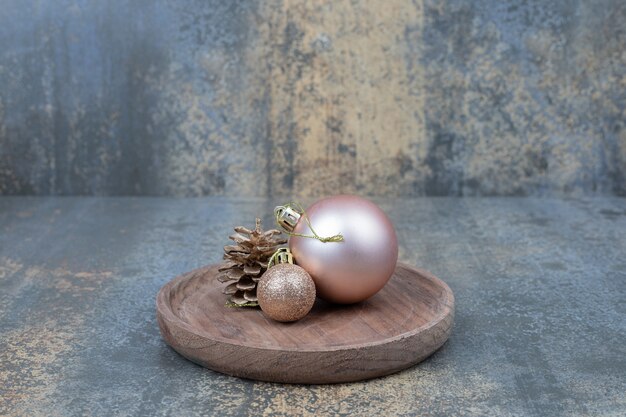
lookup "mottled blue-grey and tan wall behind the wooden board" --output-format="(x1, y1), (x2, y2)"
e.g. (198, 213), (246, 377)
(0, 0), (626, 196)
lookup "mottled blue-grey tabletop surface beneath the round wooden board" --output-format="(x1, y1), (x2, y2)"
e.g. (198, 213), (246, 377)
(0, 197), (626, 416)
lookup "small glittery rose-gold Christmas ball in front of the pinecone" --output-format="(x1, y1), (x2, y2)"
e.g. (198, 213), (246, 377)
(257, 263), (315, 322)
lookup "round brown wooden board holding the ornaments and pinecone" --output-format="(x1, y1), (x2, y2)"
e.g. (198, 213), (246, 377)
(156, 264), (454, 384)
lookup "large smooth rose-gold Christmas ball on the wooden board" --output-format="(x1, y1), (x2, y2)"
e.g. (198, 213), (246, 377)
(289, 195), (398, 304)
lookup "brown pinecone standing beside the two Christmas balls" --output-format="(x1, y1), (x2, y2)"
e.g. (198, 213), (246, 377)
(217, 218), (287, 307)
